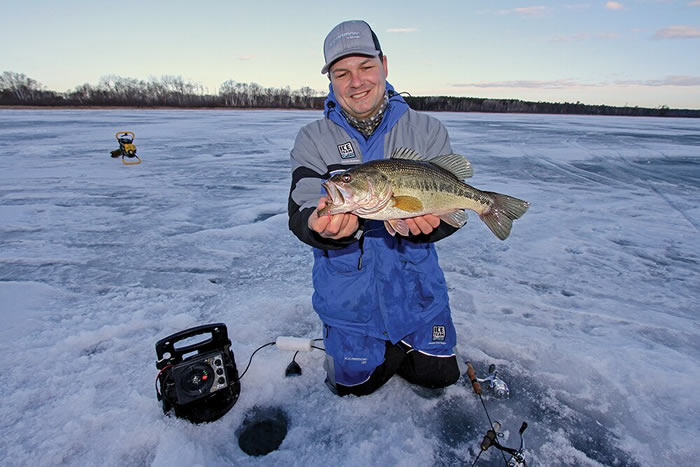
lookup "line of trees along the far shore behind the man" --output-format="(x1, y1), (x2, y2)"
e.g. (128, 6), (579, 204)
(0, 71), (700, 117)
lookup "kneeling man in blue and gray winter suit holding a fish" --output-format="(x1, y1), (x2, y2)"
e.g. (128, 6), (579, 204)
(289, 21), (462, 396)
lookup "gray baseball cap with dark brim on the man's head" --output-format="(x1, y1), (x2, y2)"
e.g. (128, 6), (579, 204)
(321, 20), (382, 75)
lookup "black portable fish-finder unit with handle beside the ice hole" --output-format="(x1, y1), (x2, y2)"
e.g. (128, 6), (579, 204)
(156, 323), (241, 423)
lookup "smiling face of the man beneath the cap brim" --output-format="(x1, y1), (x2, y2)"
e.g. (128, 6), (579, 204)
(330, 55), (387, 120)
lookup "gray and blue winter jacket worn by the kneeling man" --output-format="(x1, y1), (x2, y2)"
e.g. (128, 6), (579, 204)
(289, 83), (456, 343)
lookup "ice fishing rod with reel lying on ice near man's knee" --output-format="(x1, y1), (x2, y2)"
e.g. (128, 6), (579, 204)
(467, 362), (527, 467)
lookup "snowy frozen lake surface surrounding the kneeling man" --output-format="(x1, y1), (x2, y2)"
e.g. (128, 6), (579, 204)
(0, 110), (700, 466)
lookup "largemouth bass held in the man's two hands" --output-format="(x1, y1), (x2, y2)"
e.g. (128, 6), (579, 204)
(318, 148), (530, 240)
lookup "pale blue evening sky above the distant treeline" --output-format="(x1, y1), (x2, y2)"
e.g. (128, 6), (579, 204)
(0, 0), (700, 109)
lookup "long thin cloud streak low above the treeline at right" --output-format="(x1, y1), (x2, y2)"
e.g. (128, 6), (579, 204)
(451, 75), (700, 89)
